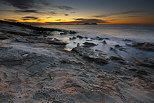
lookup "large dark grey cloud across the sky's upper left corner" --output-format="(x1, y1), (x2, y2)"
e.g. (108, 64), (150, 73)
(0, 0), (74, 13)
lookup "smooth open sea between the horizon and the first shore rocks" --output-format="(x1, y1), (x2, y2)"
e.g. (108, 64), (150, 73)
(39, 24), (154, 42)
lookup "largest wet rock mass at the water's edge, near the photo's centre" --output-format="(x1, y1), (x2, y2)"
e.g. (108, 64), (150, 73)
(72, 46), (109, 64)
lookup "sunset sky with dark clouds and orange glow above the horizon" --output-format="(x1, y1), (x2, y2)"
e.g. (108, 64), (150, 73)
(0, 0), (154, 24)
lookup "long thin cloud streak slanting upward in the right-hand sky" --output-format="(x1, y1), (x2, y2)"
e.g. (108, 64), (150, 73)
(93, 11), (142, 18)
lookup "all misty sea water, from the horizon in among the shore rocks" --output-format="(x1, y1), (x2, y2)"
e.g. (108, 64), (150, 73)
(36, 25), (154, 70)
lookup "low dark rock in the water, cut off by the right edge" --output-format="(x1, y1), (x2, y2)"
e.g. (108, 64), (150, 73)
(126, 42), (154, 51)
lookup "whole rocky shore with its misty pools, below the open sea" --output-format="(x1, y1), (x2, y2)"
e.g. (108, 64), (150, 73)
(0, 21), (154, 103)
